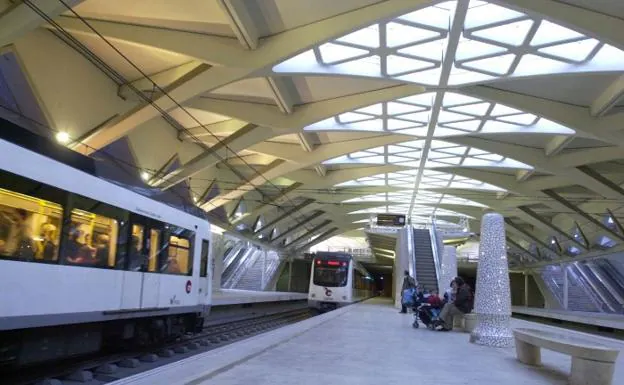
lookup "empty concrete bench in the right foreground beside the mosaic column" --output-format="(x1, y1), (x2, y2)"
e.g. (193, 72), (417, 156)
(513, 329), (619, 385)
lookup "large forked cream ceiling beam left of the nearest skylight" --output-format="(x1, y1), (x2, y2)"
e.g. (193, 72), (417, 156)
(51, 0), (431, 154)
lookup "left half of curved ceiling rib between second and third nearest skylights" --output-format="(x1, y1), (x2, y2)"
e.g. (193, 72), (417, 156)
(205, 134), (407, 209)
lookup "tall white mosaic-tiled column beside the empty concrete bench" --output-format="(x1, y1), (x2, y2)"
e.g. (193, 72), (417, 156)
(470, 213), (513, 347)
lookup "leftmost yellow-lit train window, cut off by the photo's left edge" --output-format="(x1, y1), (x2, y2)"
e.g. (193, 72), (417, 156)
(0, 186), (63, 262)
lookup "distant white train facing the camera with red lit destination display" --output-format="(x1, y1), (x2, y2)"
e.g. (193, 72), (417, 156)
(308, 252), (375, 311)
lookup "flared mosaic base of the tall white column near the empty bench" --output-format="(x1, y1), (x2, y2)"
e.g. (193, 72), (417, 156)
(470, 314), (514, 348)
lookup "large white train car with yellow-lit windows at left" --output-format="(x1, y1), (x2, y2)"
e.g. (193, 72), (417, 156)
(0, 134), (211, 367)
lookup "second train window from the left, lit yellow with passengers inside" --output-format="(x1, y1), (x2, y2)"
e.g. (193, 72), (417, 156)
(63, 209), (119, 267)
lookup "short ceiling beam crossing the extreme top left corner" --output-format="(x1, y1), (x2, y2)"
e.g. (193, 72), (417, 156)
(0, 0), (84, 47)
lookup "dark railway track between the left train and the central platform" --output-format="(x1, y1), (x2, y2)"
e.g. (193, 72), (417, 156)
(1, 309), (316, 385)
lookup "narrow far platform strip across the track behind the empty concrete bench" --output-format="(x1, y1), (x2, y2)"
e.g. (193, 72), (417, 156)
(511, 306), (624, 330)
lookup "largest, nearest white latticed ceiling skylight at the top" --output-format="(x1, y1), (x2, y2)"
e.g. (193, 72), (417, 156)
(274, 0), (624, 86)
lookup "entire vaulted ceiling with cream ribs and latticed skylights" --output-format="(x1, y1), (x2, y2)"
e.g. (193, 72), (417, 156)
(0, 0), (624, 264)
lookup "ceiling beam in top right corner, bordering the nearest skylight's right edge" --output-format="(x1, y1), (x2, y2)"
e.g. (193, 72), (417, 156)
(495, 0), (624, 50)
